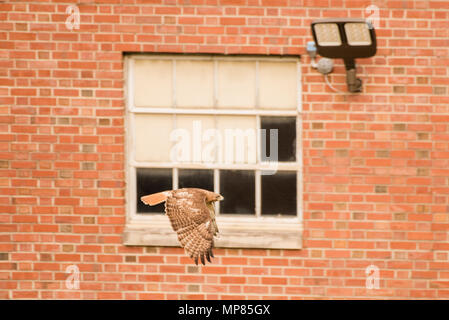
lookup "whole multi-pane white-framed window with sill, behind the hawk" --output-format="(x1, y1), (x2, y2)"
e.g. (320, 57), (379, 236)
(124, 54), (302, 248)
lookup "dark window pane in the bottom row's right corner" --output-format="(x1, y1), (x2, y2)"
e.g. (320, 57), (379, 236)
(262, 171), (296, 215)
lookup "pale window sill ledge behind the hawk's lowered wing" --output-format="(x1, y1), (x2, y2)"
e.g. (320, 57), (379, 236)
(123, 215), (302, 249)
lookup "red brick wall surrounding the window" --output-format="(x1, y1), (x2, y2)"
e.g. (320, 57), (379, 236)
(0, 0), (449, 299)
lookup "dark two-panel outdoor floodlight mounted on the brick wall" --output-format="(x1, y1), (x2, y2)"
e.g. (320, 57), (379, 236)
(312, 18), (377, 92)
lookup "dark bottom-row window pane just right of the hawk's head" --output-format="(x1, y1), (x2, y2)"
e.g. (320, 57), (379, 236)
(220, 170), (256, 214)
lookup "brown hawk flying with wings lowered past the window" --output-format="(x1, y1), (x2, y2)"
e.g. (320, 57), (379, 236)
(140, 188), (223, 264)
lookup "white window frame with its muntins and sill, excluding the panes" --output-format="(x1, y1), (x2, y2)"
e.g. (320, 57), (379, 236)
(123, 54), (303, 249)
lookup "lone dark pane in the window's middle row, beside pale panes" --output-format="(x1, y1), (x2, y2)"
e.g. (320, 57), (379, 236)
(261, 117), (296, 162)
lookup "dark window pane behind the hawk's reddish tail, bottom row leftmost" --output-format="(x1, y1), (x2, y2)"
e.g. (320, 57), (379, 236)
(136, 168), (172, 213)
